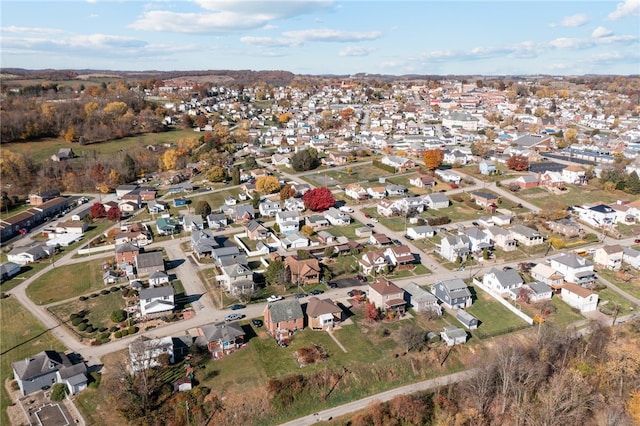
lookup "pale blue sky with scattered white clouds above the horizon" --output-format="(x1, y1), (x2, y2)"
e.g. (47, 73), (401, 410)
(0, 0), (640, 75)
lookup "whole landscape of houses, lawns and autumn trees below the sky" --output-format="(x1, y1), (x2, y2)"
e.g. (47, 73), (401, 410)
(0, 70), (640, 425)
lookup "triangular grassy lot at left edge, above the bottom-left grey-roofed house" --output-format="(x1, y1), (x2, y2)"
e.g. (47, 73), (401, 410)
(0, 298), (66, 425)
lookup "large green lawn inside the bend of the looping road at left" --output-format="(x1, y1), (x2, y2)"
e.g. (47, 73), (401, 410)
(27, 257), (108, 305)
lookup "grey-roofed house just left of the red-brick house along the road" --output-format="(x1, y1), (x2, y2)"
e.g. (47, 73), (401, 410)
(195, 322), (246, 359)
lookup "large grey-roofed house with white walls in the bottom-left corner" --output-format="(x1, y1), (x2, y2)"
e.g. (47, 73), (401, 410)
(11, 351), (88, 395)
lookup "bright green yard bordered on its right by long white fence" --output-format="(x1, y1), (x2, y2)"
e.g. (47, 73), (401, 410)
(467, 287), (528, 338)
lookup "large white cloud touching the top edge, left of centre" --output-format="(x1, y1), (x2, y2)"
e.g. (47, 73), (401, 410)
(129, 0), (332, 33)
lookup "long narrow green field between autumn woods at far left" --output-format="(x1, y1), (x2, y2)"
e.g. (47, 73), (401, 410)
(3, 129), (195, 163)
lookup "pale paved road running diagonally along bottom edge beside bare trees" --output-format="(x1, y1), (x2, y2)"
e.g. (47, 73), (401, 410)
(282, 370), (477, 426)
